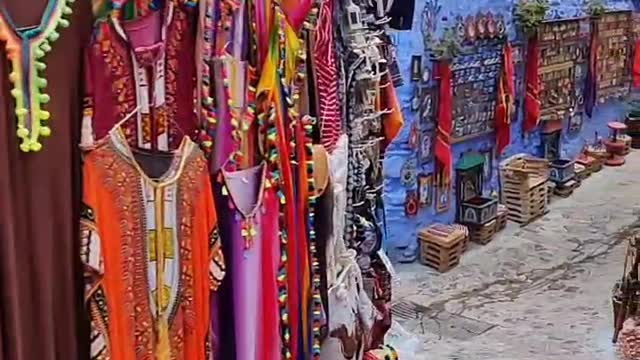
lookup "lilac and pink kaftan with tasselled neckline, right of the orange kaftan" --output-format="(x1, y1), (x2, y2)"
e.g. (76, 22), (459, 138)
(213, 164), (281, 360)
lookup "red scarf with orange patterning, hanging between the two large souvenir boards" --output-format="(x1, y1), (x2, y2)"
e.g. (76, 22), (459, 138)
(495, 42), (515, 156)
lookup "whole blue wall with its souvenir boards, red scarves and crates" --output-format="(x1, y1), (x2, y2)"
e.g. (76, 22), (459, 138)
(385, 0), (640, 270)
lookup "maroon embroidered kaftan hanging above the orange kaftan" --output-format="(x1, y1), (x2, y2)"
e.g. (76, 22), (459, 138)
(81, 1), (198, 150)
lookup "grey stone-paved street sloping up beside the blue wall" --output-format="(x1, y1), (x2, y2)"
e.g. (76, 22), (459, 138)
(391, 152), (640, 360)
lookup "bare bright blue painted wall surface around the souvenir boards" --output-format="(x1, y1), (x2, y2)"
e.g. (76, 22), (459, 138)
(384, 0), (633, 255)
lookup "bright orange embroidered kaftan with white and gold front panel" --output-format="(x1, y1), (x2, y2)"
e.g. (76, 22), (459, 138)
(80, 129), (224, 360)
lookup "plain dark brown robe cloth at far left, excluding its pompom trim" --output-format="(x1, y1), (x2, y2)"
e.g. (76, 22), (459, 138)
(0, 0), (91, 360)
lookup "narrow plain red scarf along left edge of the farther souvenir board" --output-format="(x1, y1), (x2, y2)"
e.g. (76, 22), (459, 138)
(524, 36), (540, 132)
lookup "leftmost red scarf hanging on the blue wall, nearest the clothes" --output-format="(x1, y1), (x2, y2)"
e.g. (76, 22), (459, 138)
(434, 60), (453, 182)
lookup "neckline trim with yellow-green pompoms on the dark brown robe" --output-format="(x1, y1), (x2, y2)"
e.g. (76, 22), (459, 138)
(0, 0), (75, 152)
